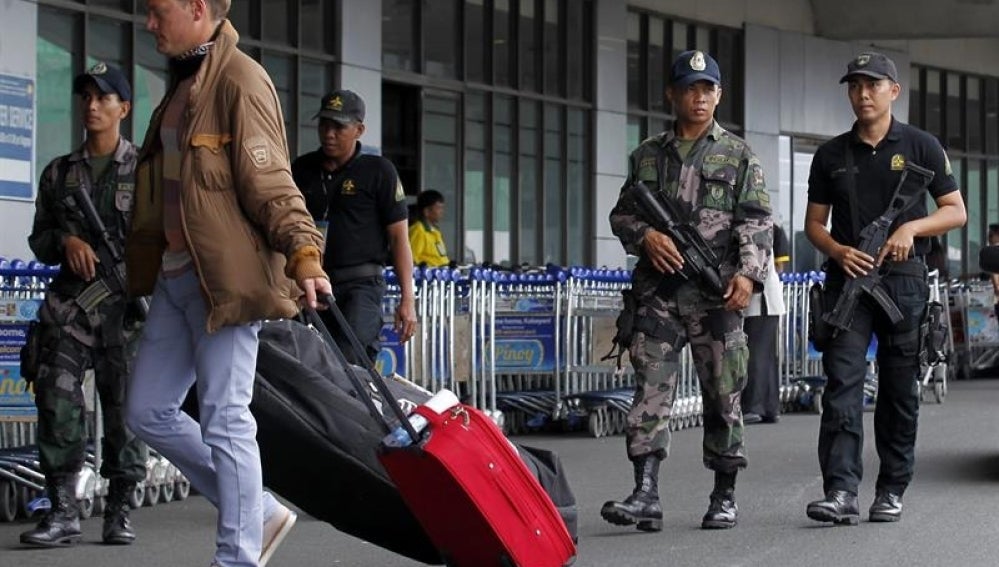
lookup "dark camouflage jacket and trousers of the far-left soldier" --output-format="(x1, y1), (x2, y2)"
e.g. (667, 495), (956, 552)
(28, 139), (146, 482)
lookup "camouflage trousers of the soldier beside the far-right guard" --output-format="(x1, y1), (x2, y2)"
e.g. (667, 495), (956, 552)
(627, 284), (749, 472)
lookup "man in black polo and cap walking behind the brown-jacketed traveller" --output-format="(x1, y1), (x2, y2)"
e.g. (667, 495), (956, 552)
(291, 90), (416, 362)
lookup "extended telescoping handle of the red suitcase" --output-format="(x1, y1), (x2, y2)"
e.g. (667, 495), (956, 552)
(305, 294), (420, 440)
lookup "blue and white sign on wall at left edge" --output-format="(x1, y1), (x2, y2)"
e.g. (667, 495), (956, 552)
(0, 74), (35, 199)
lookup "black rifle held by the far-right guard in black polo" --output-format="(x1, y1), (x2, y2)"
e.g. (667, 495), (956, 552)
(822, 163), (934, 335)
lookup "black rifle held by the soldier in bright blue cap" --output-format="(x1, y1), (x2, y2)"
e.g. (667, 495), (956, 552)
(631, 181), (725, 296)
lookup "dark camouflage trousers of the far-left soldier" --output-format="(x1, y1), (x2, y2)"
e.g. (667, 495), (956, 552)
(34, 293), (148, 482)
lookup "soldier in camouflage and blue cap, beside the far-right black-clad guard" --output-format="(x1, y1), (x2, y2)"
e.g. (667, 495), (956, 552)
(601, 51), (772, 531)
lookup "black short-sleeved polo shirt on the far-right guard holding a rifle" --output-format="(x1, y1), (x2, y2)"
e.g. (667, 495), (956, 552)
(808, 118), (958, 256)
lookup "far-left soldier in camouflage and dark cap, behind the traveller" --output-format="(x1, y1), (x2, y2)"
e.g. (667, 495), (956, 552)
(21, 63), (146, 547)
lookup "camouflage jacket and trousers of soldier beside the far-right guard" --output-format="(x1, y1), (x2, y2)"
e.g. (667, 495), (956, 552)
(610, 122), (772, 472)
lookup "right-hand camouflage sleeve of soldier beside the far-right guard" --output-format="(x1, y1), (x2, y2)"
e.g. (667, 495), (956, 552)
(733, 152), (773, 288)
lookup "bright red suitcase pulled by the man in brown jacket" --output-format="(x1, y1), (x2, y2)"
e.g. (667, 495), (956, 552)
(379, 404), (576, 567)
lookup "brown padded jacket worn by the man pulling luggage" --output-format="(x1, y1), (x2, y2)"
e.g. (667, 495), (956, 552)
(126, 21), (323, 332)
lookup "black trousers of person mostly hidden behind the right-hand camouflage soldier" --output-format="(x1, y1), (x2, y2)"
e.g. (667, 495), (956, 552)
(742, 315), (780, 417)
